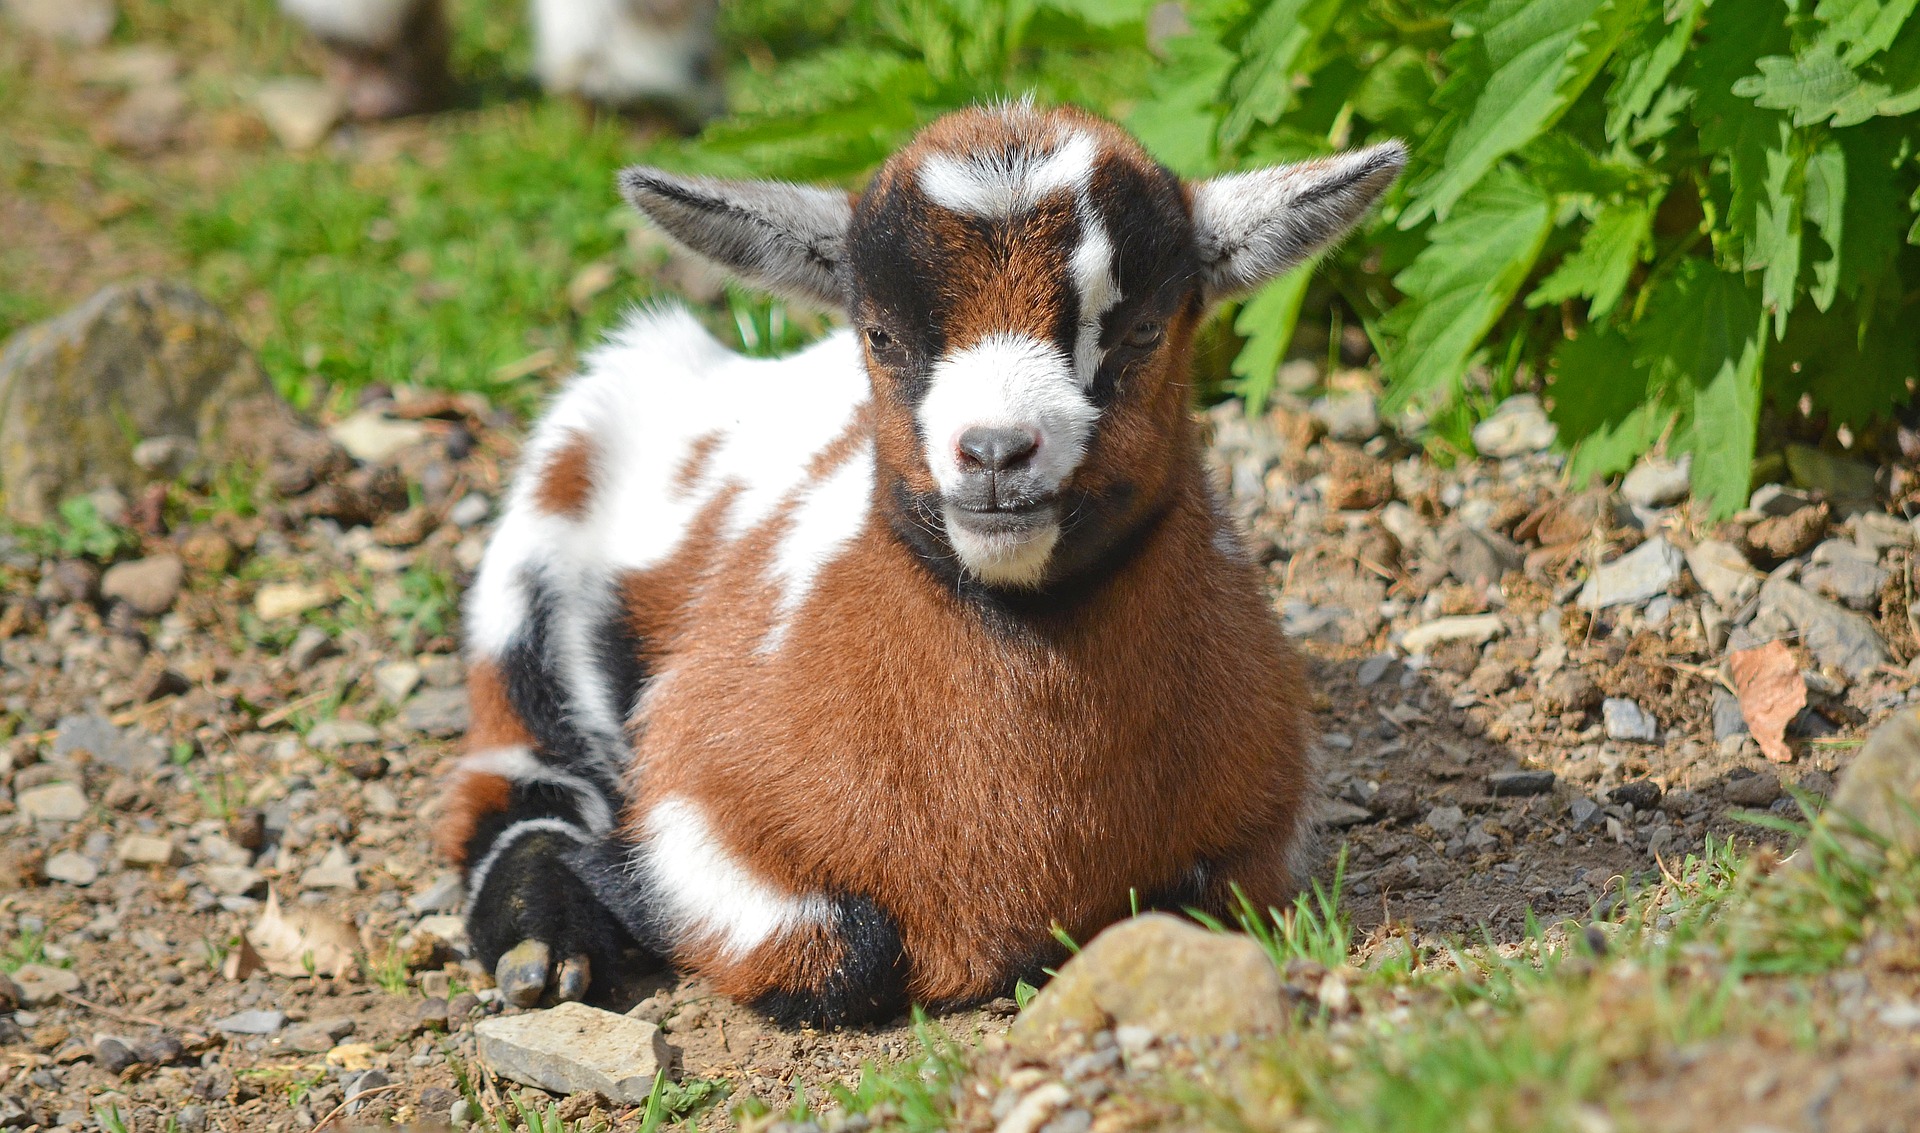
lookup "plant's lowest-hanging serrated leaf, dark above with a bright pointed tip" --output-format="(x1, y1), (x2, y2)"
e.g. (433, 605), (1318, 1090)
(1632, 257), (1766, 518)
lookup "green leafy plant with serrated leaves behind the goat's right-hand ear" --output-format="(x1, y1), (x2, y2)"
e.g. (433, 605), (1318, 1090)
(1131, 0), (1920, 515)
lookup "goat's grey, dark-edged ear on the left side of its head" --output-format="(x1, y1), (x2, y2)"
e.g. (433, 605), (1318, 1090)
(620, 165), (852, 309)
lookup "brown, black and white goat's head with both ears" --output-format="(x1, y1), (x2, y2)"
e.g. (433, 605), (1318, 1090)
(620, 104), (1405, 588)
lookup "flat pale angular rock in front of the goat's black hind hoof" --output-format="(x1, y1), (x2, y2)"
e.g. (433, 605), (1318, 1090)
(474, 1002), (672, 1106)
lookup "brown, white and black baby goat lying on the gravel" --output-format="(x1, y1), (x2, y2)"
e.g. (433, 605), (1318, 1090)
(440, 104), (1405, 1024)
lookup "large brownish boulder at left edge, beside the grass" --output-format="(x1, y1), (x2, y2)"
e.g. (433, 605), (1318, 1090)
(0, 280), (294, 524)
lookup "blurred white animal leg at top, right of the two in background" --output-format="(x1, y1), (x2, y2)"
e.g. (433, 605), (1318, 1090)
(532, 0), (722, 125)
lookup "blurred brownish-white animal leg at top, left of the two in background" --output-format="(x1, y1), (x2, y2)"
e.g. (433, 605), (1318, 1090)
(280, 0), (451, 119)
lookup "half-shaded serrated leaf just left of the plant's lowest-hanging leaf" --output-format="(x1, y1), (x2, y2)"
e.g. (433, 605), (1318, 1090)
(1548, 326), (1674, 484)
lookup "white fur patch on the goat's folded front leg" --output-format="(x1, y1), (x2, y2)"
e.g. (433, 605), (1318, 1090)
(632, 799), (833, 960)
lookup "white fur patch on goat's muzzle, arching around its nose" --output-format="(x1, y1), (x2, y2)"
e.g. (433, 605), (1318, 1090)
(920, 334), (1100, 492)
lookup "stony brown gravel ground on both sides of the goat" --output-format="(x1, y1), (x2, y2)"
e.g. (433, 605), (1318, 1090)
(0, 374), (1914, 1131)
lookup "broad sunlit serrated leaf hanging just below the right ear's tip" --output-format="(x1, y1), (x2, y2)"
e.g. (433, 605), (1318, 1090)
(1375, 165), (1553, 409)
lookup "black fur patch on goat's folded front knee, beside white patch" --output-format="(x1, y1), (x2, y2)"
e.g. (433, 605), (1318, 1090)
(751, 895), (908, 1027)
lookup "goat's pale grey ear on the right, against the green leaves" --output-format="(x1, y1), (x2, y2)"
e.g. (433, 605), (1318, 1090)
(1192, 142), (1407, 301)
